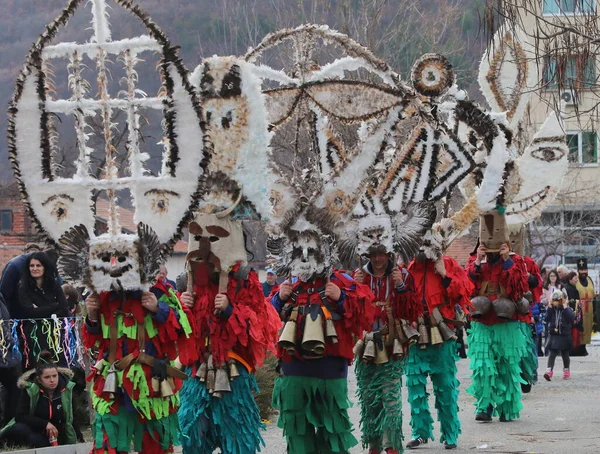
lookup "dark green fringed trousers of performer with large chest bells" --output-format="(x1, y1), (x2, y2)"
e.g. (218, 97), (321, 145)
(273, 376), (357, 454)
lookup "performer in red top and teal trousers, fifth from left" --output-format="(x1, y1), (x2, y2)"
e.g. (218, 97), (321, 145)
(406, 252), (474, 449)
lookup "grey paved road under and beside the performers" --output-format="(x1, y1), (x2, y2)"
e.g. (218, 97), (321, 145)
(263, 335), (600, 454)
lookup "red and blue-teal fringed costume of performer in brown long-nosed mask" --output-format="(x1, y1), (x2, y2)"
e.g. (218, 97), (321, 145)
(179, 262), (281, 454)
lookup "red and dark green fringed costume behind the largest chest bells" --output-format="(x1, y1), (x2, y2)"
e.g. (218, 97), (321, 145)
(271, 270), (375, 454)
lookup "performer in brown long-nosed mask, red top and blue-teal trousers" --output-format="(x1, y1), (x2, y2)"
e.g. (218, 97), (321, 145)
(179, 214), (281, 454)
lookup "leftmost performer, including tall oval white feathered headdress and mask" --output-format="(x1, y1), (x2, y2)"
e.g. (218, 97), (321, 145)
(9, 0), (210, 454)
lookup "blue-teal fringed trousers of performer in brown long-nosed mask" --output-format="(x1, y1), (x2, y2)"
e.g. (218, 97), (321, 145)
(178, 366), (265, 454)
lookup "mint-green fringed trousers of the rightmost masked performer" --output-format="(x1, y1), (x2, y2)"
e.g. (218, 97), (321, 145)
(467, 321), (528, 421)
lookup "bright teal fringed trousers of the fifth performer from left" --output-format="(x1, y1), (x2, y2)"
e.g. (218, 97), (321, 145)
(406, 340), (461, 444)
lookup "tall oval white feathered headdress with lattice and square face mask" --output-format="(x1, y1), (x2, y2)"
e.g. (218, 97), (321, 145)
(8, 0), (208, 291)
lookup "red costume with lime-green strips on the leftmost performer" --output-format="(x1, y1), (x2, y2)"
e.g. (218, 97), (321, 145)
(83, 283), (194, 454)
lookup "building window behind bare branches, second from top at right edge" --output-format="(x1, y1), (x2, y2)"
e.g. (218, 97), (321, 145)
(544, 55), (596, 90)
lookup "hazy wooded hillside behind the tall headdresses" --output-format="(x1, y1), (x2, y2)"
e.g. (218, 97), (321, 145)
(0, 0), (486, 180)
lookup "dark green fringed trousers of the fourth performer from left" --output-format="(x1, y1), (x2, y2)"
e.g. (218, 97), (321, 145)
(355, 360), (405, 452)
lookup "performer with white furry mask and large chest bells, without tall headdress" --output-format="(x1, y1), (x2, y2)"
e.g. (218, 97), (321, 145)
(271, 219), (374, 454)
